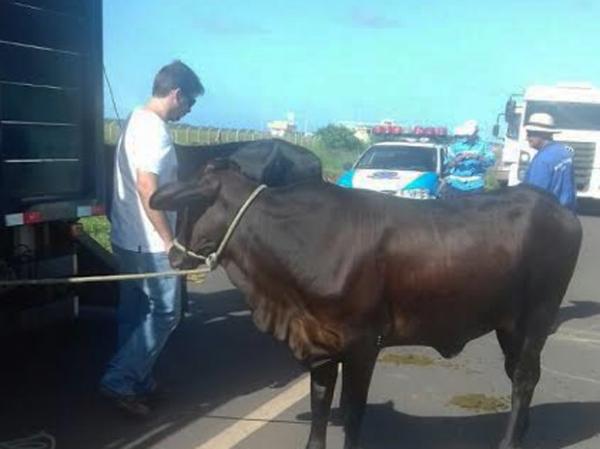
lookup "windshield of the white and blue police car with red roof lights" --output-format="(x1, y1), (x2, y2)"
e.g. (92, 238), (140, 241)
(356, 145), (437, 171)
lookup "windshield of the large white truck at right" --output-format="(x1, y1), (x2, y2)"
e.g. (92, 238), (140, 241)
(525, 101), (600, 131)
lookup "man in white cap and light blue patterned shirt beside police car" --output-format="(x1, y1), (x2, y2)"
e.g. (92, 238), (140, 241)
(440, 120), (495, 198)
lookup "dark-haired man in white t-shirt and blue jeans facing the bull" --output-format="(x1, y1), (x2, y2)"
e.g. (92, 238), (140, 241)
(100, 61), (204, 415)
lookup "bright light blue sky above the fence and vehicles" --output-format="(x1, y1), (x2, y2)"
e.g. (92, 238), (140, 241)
(104, 0), (600, 135)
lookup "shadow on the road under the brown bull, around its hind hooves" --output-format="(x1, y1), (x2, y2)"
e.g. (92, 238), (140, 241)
(297, 401), (600, 449)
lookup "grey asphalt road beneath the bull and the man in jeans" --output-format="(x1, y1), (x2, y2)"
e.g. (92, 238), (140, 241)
(0, 217), (600, 449)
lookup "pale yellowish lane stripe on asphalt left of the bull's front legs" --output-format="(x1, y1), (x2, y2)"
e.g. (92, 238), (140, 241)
(195, 375), (310, 449)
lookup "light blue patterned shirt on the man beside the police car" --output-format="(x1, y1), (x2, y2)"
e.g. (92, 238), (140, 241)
(445, 138), (496, 190)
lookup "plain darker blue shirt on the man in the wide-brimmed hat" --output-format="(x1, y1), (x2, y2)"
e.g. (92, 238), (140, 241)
(524, 142), (577, 211)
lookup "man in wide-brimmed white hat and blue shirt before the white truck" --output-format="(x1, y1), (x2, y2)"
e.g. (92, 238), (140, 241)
(523, 112), (577, 211)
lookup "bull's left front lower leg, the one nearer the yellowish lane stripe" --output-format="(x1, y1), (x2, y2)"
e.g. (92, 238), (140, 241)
(306, 362), (338, 449)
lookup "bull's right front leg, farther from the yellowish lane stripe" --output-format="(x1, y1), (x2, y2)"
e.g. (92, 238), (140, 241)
(340, 344), (379, 449)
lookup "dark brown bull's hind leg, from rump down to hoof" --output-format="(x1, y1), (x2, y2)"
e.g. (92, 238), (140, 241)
(497, 204), (582, 449)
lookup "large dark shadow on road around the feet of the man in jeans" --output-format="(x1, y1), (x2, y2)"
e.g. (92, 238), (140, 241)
(0, 291), (302, 449)
